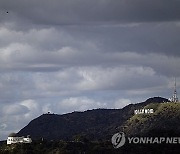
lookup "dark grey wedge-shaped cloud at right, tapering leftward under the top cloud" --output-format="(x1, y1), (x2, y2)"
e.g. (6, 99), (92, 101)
(64, 22), (180, 56)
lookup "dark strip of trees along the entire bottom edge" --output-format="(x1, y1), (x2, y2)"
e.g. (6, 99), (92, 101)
(0, 141), (180, 154)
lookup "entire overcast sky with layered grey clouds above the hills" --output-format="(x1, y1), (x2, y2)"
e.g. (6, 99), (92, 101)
(0, 0), (180, 140)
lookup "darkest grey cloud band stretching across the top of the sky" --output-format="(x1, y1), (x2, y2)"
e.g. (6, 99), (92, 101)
(0, 0), (180, 25)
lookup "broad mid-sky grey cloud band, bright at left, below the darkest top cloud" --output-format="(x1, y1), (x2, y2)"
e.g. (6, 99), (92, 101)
(0, 23), (179, 76)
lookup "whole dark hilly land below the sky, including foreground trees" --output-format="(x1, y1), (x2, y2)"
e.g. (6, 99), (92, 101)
(0, 97), (180, 154)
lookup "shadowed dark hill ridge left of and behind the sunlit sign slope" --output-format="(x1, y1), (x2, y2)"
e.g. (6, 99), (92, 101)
(18, 97), (168, 140)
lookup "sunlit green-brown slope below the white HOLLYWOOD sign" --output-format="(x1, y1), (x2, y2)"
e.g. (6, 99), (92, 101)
(124, 103), (180, 136)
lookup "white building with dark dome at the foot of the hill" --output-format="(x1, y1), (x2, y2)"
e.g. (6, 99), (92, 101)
(7, 133), (32, 144)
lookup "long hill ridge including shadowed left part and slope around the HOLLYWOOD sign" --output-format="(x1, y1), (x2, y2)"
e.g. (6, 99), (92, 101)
(18, 97), (172, 140)
